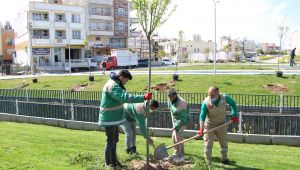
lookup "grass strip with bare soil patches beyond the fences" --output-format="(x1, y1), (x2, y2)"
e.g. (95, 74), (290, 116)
(0, 74), (300, 96)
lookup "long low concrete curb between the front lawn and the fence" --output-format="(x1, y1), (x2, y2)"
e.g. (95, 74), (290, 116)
(0, 113), (300, 146)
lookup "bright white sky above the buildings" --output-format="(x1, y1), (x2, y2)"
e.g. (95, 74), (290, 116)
(0, 0), (300, 47)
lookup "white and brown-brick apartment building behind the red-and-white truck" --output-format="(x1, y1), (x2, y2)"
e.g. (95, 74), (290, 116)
(64, 0), (129, 57)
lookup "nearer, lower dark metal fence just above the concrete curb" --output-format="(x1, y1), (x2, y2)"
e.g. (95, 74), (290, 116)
(0, 100), (300, 136)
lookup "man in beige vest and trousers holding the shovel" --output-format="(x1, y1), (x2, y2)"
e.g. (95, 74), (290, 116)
(198, 86), (239, 164)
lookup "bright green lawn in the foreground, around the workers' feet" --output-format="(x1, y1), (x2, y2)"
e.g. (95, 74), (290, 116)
(0, 122), (300, 170)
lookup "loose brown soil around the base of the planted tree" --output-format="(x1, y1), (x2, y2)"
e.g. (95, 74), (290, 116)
(131, 160), (193, 170)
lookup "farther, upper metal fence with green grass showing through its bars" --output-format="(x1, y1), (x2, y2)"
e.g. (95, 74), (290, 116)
(0, 89), (300, 114)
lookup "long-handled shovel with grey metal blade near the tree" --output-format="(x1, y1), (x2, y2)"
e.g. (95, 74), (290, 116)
(154, 120), (232, 160)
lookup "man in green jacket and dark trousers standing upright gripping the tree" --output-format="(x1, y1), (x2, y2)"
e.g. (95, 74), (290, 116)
(99, 70), (152, 168)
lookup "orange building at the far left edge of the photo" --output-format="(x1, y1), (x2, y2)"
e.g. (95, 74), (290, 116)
(1, 22), (15, 64)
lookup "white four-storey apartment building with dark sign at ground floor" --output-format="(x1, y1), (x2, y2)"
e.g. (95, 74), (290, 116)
(15, 0), (86, 70)
